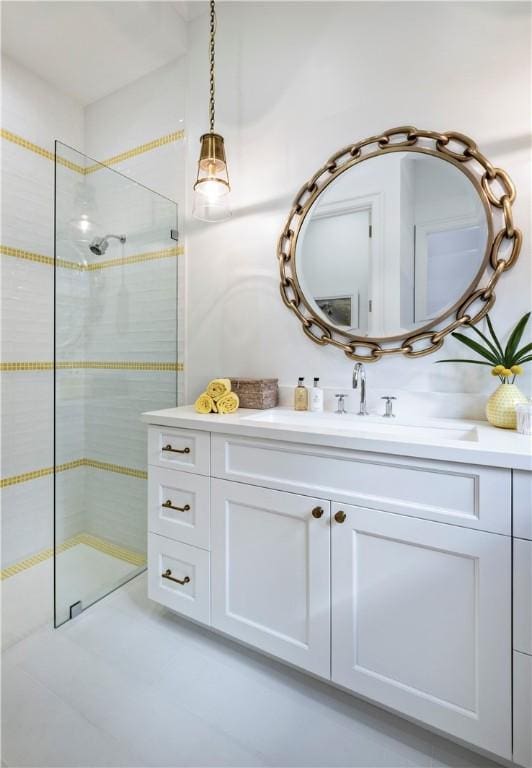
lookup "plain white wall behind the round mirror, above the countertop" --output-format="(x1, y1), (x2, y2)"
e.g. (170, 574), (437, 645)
(187, 2), (531, 414)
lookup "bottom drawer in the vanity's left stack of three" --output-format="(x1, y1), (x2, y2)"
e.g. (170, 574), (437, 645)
(148, 533), (211, 624)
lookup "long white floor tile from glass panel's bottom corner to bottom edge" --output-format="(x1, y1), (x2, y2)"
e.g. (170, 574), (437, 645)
(1, 630), (264, 766)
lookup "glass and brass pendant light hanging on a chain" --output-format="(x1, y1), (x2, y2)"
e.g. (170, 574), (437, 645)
(192, 0), (231, 221)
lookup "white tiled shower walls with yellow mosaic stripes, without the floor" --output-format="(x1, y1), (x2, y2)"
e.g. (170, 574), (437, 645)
(1, 54), (184, 575)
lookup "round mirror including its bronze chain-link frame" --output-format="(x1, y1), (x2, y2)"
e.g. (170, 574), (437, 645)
(278, 127), (521, 360)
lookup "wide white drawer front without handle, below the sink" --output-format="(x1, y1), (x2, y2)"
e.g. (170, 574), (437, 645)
(213, 435), (511, 535)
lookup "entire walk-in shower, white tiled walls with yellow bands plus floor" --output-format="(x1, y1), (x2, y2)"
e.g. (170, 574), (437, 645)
(0, 51), (184, 645)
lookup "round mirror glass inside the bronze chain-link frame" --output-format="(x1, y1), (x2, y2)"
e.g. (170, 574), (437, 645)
(295, 151), (488, 338)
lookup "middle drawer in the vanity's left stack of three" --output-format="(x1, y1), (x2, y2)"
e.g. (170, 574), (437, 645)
(148, 467), (210, 549)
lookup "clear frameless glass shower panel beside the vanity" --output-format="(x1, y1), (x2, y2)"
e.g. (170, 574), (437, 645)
(54, 142), (179, 626)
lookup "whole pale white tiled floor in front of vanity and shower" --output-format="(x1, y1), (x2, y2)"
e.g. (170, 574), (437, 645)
(3, 575), (504, 768)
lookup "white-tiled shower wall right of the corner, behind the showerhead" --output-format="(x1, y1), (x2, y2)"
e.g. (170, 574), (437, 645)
(80, 60), (185, 550)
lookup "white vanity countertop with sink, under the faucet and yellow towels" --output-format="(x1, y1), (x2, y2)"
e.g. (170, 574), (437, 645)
(142, 405), (532, 471)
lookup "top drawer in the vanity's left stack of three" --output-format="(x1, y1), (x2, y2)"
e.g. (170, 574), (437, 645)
(148, 427), (211, 475)
